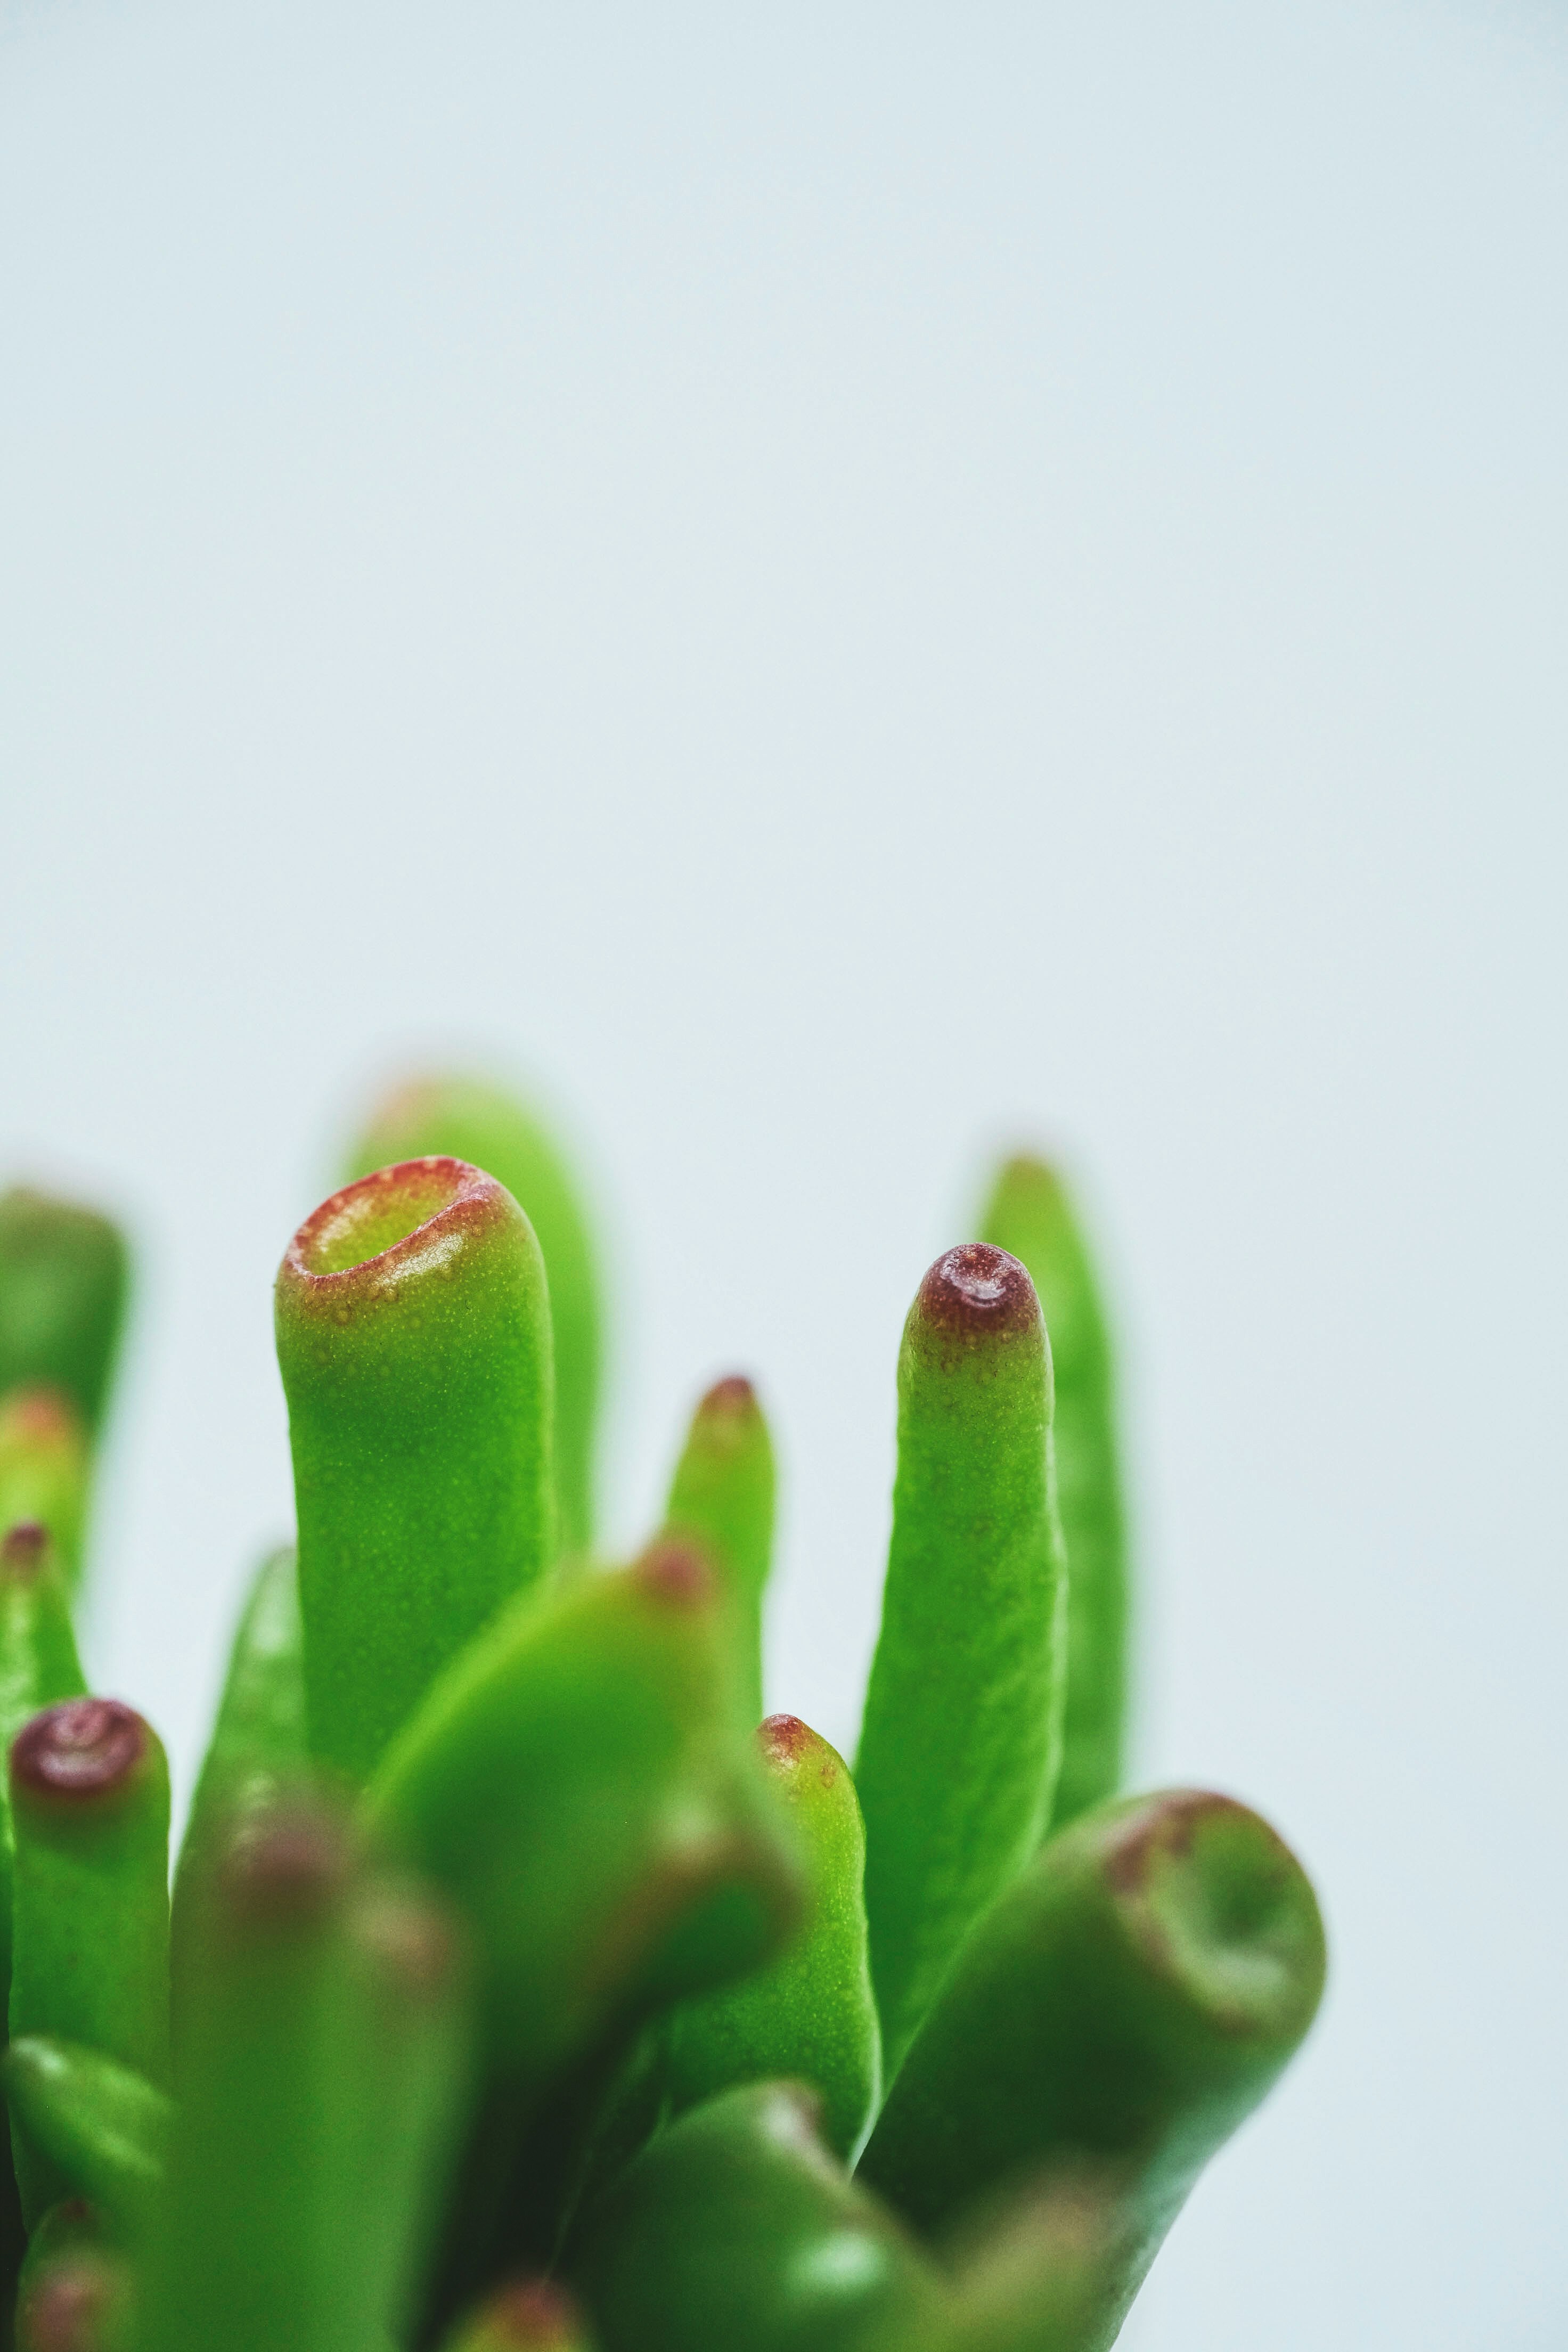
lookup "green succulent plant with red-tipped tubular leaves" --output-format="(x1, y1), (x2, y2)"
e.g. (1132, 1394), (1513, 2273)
(0, 1080), (1324, 2352)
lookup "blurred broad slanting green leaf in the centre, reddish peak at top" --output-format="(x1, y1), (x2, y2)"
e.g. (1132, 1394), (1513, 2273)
(367, 1540), (802, 2084)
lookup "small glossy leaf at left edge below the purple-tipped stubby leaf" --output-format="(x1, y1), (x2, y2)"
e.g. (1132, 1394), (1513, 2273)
(0, 2035), (174, 2237)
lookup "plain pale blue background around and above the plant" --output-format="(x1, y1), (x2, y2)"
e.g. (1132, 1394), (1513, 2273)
(0, 0), (1568, 2352)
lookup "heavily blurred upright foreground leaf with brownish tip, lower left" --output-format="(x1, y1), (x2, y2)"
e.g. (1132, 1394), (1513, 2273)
(143, 1799), (374, 2352)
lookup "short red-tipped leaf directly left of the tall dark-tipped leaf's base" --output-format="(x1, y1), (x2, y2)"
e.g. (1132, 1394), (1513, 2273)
(665, 1714), (881, 2161)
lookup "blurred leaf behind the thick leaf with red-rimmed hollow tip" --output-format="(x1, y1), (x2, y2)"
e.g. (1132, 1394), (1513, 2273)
(348, 1077), (602, 1555)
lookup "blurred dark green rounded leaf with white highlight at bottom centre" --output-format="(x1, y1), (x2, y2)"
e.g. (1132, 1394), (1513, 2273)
(574, 2084), (943, 2352)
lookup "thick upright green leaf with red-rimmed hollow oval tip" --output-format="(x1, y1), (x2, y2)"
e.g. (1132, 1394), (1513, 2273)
(277, 1159), (555, 1781)
